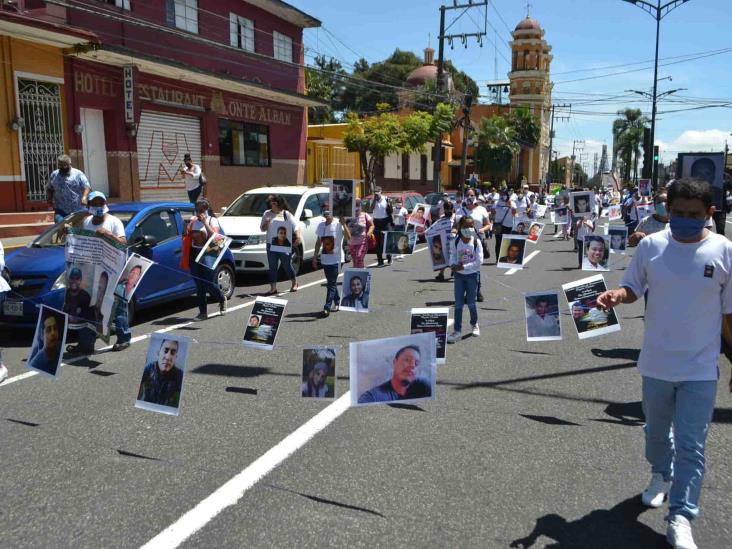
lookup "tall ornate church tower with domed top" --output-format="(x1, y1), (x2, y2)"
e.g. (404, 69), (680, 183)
(508, 15), (553, 185)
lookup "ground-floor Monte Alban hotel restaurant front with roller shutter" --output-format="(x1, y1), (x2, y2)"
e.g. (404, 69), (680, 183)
(66, 48), (319, 208)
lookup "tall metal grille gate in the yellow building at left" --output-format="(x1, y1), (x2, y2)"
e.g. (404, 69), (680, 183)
(18, 79), (64, 200)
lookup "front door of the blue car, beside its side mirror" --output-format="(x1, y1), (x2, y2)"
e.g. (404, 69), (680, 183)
(130, 209), (193, 303)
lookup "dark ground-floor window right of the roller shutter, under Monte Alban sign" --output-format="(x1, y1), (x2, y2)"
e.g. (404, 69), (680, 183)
(219, 118), (271, 168)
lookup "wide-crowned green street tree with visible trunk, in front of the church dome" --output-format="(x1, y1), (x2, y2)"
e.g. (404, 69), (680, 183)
(343, 103), (453, 192)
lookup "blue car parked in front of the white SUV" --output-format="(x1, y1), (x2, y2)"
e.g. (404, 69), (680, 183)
(0, 202), (236, 328)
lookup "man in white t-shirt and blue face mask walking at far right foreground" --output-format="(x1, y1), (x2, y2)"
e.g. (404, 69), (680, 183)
(597, 179), (732, 548)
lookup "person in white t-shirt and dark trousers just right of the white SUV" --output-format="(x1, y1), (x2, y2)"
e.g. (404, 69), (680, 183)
(313, 209), (351, 318)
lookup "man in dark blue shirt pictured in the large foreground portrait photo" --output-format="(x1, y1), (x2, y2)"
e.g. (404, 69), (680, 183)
(358, 345), (432, 404)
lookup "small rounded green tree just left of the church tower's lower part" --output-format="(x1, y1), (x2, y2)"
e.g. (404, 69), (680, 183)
(475, 115), (521, 181)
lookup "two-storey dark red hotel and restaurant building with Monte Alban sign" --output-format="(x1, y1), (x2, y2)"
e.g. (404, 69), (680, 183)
(5, 0), (320, 208)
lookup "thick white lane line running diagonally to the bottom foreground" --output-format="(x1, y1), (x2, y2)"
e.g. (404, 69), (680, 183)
(142, 391), (351, 549)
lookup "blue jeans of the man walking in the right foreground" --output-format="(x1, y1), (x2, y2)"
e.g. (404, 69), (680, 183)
(643, 377), (717, 520)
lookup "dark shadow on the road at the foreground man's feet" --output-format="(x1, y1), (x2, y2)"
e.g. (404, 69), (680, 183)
(511, 496), (668, 549)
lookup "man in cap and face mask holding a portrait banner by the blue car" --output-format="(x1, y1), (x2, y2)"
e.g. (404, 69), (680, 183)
(68, 191), (132, 355)
